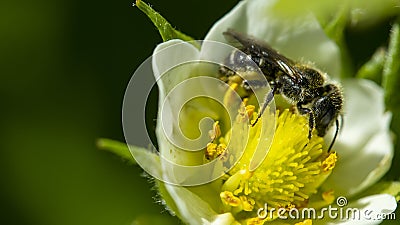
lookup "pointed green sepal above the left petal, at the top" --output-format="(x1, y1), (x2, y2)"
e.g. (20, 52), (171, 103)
(134, 0), (194, 42)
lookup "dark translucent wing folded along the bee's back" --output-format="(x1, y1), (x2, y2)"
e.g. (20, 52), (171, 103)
(223, 29), (300, 79)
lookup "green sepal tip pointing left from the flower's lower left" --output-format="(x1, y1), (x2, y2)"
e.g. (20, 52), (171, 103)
(97, 138), (137, 164)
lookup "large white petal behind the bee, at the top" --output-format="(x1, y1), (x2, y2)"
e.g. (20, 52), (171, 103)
(205, 0), (341, 77)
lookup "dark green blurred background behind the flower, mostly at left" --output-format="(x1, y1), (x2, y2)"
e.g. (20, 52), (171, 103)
(0, 0), (396, 225)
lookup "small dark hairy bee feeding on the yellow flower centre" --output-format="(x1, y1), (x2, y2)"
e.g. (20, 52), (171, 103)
(220, 29), (343, 152)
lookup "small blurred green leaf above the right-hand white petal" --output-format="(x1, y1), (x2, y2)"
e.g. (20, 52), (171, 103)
(356, 48), (386, 85)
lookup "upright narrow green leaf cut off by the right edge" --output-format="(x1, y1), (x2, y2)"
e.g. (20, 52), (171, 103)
(382, 22), (400, 113)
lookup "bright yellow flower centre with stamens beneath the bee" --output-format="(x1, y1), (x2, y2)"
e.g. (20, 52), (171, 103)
(206, 103), (337, 224)
